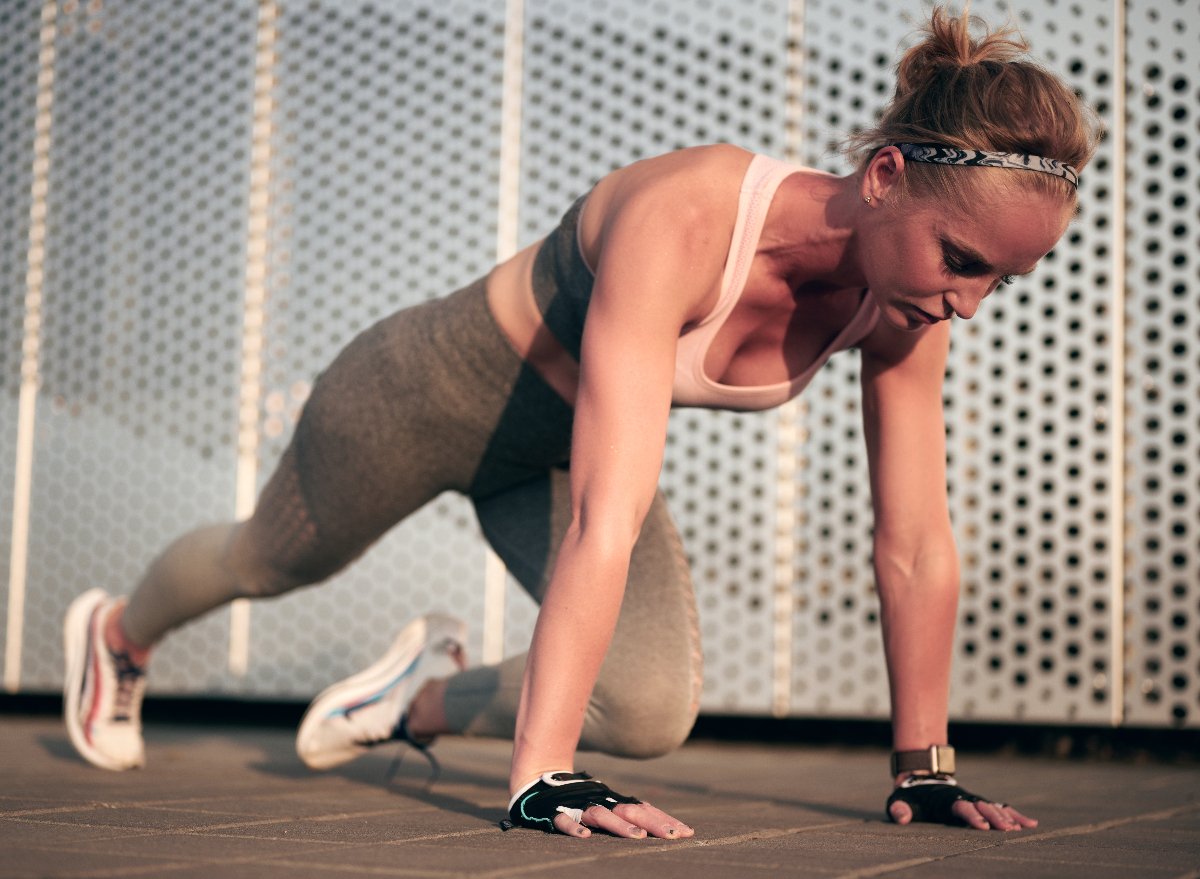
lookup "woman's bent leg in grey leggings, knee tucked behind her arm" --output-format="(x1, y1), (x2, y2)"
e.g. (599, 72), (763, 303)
(445, 468), (703, 758)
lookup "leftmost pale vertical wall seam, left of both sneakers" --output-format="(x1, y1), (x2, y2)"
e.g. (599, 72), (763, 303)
(4, 0), (59, 693)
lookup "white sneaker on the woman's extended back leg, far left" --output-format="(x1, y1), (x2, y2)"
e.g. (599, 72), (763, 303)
(62, 588), (146, 771)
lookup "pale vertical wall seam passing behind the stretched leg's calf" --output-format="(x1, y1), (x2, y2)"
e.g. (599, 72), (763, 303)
(229, 0), (278, 676)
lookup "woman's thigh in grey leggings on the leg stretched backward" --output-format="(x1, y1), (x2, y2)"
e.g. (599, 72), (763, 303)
(247, 280), (522, 582)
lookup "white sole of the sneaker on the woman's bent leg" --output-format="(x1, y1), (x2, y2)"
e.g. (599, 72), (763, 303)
(296, 614), (466, 770)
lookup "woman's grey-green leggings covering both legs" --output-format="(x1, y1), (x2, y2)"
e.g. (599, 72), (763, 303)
(124, 280), (702, 757)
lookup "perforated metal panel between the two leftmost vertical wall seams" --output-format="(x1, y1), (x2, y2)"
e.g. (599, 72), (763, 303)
(15, 2), (254, 690)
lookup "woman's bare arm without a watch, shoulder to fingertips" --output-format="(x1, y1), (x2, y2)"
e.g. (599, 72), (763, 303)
(510, 151), (737, 835)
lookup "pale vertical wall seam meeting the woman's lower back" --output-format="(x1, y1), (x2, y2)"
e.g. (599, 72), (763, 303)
(482, 0), (524, 665)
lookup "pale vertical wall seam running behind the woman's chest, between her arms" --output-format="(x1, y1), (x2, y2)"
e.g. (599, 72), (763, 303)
(770, 0), (806, 717)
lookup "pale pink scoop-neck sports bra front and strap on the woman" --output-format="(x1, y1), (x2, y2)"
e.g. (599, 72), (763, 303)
(671, 155), (880, 412)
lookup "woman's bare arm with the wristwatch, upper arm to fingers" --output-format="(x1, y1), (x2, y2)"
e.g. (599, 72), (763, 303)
(863, 322), (1037, 830)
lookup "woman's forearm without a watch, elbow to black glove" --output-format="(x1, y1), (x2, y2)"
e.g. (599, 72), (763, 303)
(509, 527), (632, 791)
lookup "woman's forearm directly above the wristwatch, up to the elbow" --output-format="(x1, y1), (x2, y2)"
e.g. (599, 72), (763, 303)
(875, 539), (959, 751)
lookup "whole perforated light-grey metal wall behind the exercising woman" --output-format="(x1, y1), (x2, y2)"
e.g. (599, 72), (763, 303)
(0, 0), (1200, 724)
